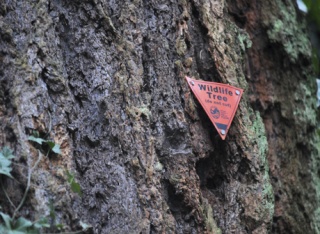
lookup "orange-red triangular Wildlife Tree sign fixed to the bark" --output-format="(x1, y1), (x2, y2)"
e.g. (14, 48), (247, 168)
(186, 76), (243, 140)
